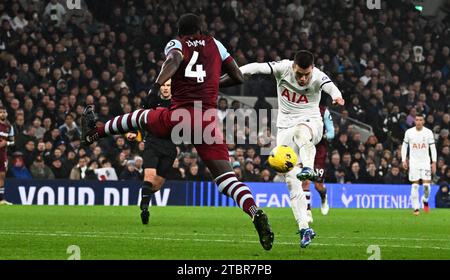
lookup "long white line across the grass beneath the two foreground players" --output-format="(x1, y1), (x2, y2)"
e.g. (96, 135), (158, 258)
(0, 231), (450, 250)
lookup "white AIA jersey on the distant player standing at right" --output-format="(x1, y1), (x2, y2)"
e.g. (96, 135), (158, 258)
(402, 127), (436, 168)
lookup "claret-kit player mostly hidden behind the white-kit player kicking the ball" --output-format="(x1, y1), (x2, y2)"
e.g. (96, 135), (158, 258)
(302, 105), (334, 223)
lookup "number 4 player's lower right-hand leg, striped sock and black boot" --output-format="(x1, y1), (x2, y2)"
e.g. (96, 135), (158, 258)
(215, 171), (274, 250)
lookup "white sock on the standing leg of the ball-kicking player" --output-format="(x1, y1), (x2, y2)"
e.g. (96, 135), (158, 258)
(285, 166), (309, 230)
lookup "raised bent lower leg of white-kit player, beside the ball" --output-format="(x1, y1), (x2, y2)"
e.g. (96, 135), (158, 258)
(294, 124), (317, 181)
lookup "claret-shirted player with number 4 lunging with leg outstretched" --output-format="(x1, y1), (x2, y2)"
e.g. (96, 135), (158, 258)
(82, 14), (274, 250)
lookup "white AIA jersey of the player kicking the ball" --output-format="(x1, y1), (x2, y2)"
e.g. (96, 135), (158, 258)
(268, 59), (331, 128)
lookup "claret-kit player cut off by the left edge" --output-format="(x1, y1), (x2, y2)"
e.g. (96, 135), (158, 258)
(0, 106), (14, 205)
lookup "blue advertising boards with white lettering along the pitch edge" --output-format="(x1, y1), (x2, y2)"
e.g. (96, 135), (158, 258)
(5, 179), (438, 208)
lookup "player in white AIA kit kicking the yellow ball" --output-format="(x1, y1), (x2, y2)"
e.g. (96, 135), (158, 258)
(221, 50), (345, 247)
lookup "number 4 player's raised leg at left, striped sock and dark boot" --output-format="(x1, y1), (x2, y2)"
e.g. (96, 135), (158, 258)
(81, 105), (150, 146)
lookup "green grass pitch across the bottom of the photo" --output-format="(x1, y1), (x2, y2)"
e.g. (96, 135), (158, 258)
(0, 205), (450, 260)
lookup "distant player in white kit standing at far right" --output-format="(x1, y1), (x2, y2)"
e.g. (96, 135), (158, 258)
(402, 115), (437, 215)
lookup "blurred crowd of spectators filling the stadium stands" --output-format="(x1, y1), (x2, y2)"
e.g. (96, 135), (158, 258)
(0, 0), (450, 183)
